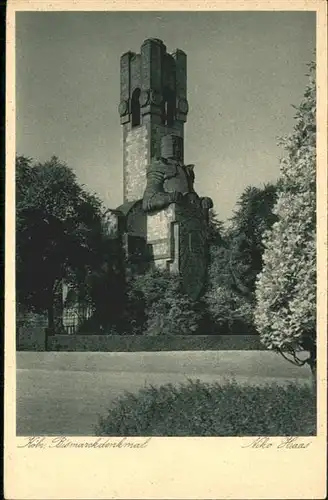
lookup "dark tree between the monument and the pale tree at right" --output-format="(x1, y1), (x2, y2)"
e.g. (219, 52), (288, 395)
(205, 184), (276, 333)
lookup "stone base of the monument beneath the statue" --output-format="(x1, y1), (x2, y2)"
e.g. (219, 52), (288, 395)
(114, 193), (208, 300)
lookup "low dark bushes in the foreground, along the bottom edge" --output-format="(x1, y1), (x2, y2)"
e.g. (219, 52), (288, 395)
(96, 380), (316, 436)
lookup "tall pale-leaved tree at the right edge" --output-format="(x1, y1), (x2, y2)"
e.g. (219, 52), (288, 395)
(255, 64), (316, 373)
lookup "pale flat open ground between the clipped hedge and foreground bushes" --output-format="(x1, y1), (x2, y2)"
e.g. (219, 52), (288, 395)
(16, 350), (311, 436)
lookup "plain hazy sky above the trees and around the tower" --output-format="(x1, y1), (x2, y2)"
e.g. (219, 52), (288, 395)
(16, 11), (315, 221)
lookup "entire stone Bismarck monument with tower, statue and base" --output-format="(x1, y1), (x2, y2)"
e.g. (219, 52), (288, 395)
(107, 38), (212, 299)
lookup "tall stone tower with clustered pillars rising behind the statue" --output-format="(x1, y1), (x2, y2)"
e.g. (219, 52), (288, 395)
(119, 38), (188, 202)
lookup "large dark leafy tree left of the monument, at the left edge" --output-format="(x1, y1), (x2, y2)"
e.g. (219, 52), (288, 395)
(16, 156), (101, 329)
